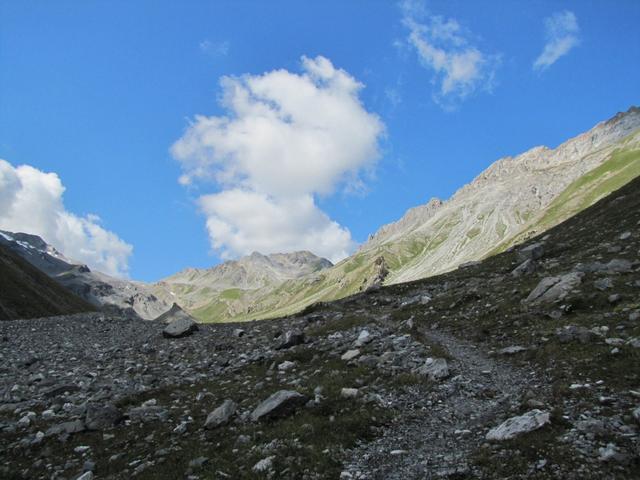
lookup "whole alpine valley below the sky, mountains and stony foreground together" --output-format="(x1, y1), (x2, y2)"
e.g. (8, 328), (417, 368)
(0, 107), (640, 480)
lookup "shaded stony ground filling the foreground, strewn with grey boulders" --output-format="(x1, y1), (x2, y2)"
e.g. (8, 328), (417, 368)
(0, 181), (640, 480)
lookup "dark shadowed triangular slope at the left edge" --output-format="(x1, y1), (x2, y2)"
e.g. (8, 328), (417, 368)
(0, 244), (94, 320)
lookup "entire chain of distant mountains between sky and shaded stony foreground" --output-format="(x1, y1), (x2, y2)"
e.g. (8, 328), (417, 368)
(0, 107), (640, 322)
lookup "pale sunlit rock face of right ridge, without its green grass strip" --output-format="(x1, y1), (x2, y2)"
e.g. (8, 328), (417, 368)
(360, 107), (640, 284)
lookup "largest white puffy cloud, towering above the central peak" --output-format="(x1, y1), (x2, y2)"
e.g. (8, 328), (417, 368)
(171, 56), (384, 261)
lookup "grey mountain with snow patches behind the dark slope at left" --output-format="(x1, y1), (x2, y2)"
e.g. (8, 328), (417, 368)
(0, 231), (170, 320)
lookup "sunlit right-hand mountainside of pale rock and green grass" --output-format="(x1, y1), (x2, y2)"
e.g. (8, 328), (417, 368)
(177, 107), (640, 321)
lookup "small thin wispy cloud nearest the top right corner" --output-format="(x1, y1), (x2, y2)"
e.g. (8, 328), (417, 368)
(533, 10), (580, 71)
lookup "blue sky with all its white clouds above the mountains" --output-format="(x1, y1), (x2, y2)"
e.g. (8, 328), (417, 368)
(0, 0), (640, 281)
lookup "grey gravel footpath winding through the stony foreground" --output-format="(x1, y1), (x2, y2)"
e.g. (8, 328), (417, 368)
(343, 331), (537, 480)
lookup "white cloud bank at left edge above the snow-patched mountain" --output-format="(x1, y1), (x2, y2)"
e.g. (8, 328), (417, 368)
(0, 159), (133, 276)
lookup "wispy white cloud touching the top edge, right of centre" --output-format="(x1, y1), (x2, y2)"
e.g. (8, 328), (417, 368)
(400, 1), (501, 109)
